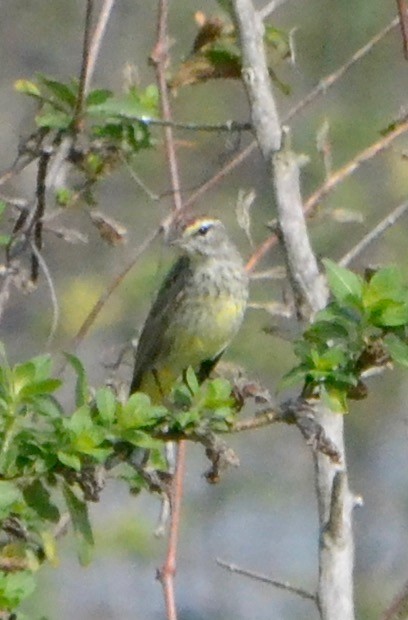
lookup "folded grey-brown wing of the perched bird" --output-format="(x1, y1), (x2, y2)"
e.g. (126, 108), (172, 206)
(130, 256), (190, 394)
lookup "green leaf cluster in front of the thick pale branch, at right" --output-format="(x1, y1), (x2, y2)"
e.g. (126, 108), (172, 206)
(282, 260), (408, 412)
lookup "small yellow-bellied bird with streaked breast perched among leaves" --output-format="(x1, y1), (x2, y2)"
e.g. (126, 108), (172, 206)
(130, 218), (248, 403)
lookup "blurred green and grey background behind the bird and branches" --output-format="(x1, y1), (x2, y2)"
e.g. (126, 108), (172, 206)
(0, 0), (408, 620)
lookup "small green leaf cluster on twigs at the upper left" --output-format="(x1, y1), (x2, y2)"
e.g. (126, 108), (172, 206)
(14, 73), (158, 206)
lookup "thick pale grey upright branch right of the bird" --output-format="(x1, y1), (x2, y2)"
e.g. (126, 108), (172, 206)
(233, 0), (354, 620)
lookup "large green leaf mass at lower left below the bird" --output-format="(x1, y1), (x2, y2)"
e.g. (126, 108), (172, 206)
(0, 350), (236, 610)
